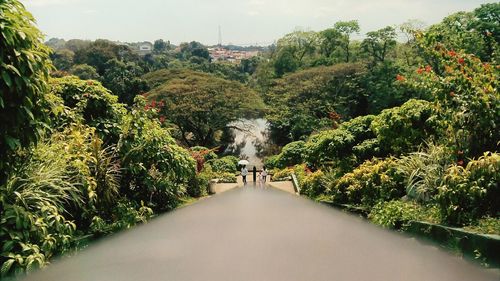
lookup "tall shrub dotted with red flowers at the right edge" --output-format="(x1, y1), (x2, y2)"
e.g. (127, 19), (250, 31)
(407, 44), (500, 158)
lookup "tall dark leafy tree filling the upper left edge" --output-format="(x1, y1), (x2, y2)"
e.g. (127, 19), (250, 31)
(0, 0), (51, 179)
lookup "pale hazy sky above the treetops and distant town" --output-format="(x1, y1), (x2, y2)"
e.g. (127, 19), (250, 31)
(21, 0), (496, 45)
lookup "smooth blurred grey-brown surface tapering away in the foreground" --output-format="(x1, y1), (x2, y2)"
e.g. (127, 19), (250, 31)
(21, 187), (500, 281)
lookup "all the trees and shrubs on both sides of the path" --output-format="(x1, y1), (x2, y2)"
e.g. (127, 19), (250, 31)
(0, 0), (500, 277)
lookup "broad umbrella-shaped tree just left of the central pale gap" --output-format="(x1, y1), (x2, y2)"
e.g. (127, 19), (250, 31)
(146, 70), (261, 147)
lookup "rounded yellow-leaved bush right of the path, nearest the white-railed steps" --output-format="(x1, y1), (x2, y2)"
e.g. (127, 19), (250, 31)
(331, 158), (404, 207)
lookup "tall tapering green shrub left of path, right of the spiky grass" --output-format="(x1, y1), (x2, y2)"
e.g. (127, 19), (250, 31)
(118, 97), (196, 211)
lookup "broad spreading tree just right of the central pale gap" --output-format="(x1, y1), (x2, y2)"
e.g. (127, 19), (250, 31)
(265, 64), (364, 144)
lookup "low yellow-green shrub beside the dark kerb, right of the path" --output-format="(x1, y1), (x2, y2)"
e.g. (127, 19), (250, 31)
(368, 200), (439, 228)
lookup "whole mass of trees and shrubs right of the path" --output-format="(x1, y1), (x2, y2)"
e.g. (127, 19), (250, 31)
(264, 3), (500, 234)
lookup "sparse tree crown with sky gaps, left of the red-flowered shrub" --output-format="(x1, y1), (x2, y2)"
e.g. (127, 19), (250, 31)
(362, 26), (397, 64)
